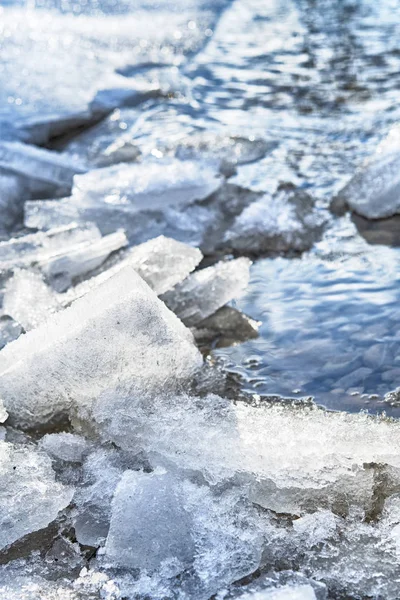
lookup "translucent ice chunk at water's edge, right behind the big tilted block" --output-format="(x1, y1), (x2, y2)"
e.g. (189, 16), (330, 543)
(162, 258), (251, 326)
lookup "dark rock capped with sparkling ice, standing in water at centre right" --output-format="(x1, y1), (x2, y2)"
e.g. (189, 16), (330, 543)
(224, 186), (326, 254)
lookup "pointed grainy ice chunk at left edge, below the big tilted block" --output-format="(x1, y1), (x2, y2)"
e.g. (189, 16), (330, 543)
(0, 442), (73, 548)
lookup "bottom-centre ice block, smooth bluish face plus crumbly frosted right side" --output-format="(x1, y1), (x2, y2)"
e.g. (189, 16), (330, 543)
(105, 469), (262, 599)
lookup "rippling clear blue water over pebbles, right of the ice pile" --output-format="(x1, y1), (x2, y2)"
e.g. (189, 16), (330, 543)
(216, 223), (400, 416)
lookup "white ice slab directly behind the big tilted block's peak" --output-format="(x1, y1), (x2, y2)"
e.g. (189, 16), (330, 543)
(64, 236), (203, 304)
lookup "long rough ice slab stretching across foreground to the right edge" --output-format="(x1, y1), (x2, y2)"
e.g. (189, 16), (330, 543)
(94, 394), (400, 506)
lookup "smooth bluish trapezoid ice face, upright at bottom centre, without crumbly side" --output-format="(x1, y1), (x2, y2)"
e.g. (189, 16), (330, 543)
(105, 470), (195, 573)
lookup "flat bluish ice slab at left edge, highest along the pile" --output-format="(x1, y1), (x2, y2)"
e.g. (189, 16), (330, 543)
(0, 142), (85, 194)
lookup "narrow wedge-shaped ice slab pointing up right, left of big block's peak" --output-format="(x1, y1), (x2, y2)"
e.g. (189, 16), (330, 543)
(42, 231), (128, 292)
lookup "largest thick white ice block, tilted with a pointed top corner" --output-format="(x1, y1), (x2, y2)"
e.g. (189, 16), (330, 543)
(0, 267), (201, 427)
